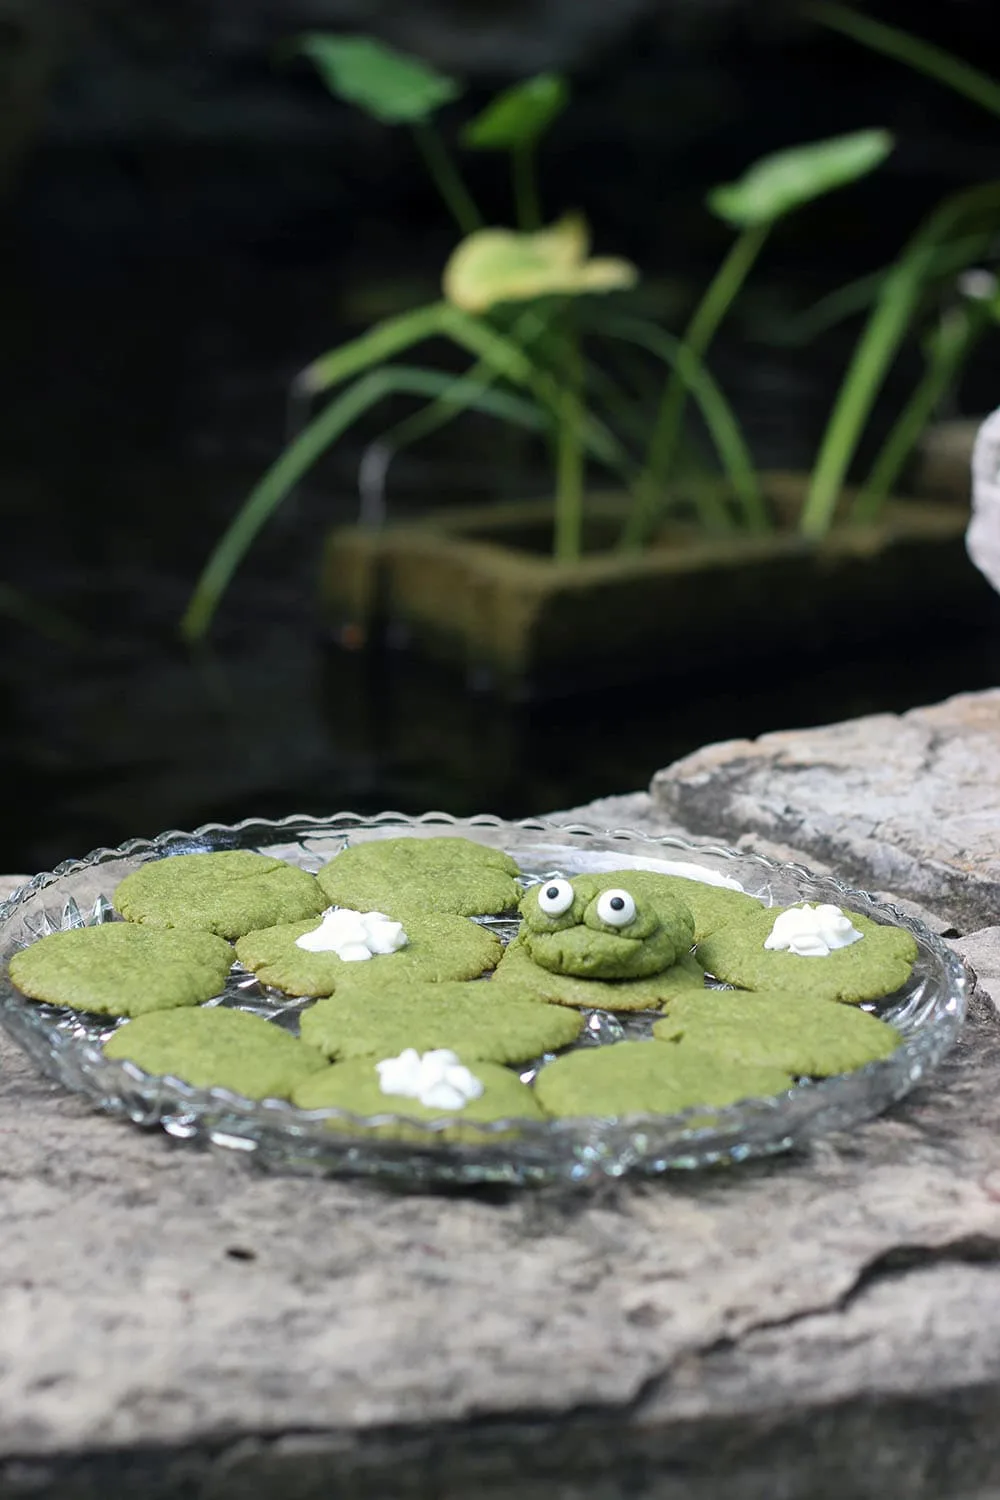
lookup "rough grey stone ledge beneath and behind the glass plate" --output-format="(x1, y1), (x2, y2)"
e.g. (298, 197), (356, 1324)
(0, 708), (1000, 1500)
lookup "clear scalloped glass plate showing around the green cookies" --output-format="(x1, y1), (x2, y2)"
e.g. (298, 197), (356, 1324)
(0, 813), (966, 1185)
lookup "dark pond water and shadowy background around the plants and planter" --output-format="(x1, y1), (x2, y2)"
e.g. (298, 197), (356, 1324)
(0, 0), (1000, 870)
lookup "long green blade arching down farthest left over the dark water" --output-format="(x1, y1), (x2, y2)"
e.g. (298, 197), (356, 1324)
(180, 365), (551, 642)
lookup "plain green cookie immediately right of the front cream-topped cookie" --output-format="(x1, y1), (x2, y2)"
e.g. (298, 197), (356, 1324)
(535, 1041), (793, 1116)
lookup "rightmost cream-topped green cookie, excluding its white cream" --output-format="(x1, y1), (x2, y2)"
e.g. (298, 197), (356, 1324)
(697, 906), (918, 1005)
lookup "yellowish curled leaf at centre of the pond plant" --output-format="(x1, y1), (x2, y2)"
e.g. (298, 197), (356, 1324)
(444, 215), (639, 312)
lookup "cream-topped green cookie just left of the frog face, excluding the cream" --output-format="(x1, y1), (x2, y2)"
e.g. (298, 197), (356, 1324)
(235, 917), (502, 996)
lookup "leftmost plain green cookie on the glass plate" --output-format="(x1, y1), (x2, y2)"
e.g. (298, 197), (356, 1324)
(10, 923), (232, 1016)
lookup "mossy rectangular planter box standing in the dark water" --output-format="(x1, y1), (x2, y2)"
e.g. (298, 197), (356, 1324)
(322, 476), (999, 698)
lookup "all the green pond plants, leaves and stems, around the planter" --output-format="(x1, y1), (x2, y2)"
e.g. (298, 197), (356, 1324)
(179, 29), (1000, 641)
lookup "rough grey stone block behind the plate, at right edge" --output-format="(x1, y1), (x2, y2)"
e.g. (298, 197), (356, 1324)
(651, 690), (1000, 932)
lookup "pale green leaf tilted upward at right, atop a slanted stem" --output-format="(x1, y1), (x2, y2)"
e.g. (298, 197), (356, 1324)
(708, 131), (894, 230)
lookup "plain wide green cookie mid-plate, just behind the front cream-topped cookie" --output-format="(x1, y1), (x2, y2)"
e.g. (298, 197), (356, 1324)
(301, 981), (583, 1062)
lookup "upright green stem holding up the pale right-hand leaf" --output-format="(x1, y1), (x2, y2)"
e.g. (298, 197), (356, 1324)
(622, 224), (771, 546)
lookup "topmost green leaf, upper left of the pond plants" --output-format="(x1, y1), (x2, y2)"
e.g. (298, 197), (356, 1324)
(290, 32), (462, 125)
